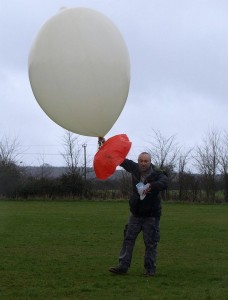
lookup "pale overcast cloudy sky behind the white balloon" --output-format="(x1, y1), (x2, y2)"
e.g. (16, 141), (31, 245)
(0, 0), (228, 166)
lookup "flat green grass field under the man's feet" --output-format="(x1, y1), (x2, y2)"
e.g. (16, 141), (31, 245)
(0, 201), (228, 300)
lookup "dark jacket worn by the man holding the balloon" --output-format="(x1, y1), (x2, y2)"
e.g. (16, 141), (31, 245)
(120, 159), (168, 217)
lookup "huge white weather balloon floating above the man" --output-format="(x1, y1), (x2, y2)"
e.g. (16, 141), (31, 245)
(29, 8), (130, 137)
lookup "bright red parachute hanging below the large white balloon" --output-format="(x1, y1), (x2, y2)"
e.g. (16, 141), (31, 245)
(93, 134), (131, 179)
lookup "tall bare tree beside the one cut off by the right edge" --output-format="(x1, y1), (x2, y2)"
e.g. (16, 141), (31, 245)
(194, 130), (220, 202)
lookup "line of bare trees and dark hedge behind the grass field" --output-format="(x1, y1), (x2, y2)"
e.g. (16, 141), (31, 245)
(0, 129), (228, 203)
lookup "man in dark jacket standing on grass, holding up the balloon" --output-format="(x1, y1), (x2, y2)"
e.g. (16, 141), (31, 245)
(109, 152), (168, 276)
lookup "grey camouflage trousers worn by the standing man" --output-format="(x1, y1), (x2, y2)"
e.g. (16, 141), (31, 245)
(119, 215), (160, 272)
